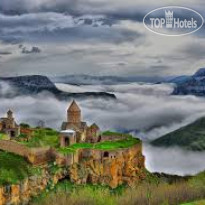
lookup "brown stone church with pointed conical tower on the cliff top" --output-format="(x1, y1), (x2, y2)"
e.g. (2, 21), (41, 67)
(61, 100), (100, 146)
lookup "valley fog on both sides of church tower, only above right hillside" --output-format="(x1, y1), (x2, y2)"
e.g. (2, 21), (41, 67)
(0, 84), (205, 139)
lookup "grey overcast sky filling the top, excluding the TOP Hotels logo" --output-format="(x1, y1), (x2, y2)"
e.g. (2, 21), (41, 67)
(0, 0), (205, 76)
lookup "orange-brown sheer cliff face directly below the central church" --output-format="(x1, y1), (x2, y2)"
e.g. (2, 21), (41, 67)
(69, 144), (145, 188)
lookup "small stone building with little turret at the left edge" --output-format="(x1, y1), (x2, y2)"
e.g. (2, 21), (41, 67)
(0, 110), (20, 139)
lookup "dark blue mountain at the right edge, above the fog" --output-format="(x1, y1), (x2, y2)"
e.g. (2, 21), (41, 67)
(172, 68), (205, 96)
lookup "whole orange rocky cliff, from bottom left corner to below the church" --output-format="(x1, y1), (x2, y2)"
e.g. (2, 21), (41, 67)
(0, 143), (146, 205)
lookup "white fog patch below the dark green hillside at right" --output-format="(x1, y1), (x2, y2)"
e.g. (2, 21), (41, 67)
(143, 144), (205, 176)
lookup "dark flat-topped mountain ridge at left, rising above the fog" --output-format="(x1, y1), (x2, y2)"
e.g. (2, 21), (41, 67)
(0, 75), (115, 100)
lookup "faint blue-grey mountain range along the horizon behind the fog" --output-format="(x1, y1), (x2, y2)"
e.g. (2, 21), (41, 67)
(50, 75), (165, 85)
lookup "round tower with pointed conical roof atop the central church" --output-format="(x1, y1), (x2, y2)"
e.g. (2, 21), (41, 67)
(67, 100), (81, 124)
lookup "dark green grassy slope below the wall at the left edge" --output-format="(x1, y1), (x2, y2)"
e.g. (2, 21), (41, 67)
(0, 151), (31, 185)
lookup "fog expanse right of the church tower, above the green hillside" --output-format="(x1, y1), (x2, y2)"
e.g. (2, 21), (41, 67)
(54, 83), (205, 140)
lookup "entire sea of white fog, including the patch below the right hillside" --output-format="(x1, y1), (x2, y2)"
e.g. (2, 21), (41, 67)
(0, 83), (205, 175)
